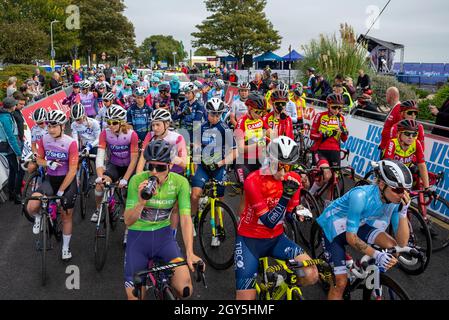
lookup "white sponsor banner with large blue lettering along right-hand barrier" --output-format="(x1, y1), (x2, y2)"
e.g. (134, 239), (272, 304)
(305, 105), (449, 218)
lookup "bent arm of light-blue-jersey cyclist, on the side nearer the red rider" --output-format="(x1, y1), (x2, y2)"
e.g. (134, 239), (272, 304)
(346, 190), (375, 257)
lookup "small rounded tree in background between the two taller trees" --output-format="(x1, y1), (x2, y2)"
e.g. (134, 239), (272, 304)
(139, 35), (187, 65)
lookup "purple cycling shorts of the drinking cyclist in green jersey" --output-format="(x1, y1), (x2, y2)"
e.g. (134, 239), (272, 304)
(125, 227), (184, 288)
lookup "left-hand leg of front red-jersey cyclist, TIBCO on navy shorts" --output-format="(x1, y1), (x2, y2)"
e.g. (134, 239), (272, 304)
(234, 236), (272, 300)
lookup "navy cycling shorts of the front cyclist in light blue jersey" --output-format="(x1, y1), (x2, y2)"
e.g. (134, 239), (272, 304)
(321, 224), (384, 275)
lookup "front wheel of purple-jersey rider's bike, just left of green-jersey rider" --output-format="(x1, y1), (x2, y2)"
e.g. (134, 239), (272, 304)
(94, 203), (111, 271)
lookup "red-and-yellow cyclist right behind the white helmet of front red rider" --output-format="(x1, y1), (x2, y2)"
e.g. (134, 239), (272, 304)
(263, 82), (297, 139)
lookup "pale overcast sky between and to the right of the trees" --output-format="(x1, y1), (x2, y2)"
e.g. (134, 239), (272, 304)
(125, 0), (449, 63)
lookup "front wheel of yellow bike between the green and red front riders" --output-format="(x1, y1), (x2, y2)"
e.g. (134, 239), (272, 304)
(198, 201), (237, 270)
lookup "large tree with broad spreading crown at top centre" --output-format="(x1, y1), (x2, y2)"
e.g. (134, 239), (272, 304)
(192, 0), (282, 67)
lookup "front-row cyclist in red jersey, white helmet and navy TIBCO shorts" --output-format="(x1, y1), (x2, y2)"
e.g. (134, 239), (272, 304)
(234, 136), (318, 300)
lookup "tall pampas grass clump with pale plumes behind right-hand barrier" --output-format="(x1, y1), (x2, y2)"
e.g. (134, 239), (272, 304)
(297, 24), (369, 84)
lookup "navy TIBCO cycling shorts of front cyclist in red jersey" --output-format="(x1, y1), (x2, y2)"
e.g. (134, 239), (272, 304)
(234, 234), (304, 290)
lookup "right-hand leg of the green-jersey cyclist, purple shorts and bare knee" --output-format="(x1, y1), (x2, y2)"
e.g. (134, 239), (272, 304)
(153, 227), (193, 299)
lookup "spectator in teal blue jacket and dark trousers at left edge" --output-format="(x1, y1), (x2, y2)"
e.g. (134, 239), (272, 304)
(0, 97), (22, 204)
